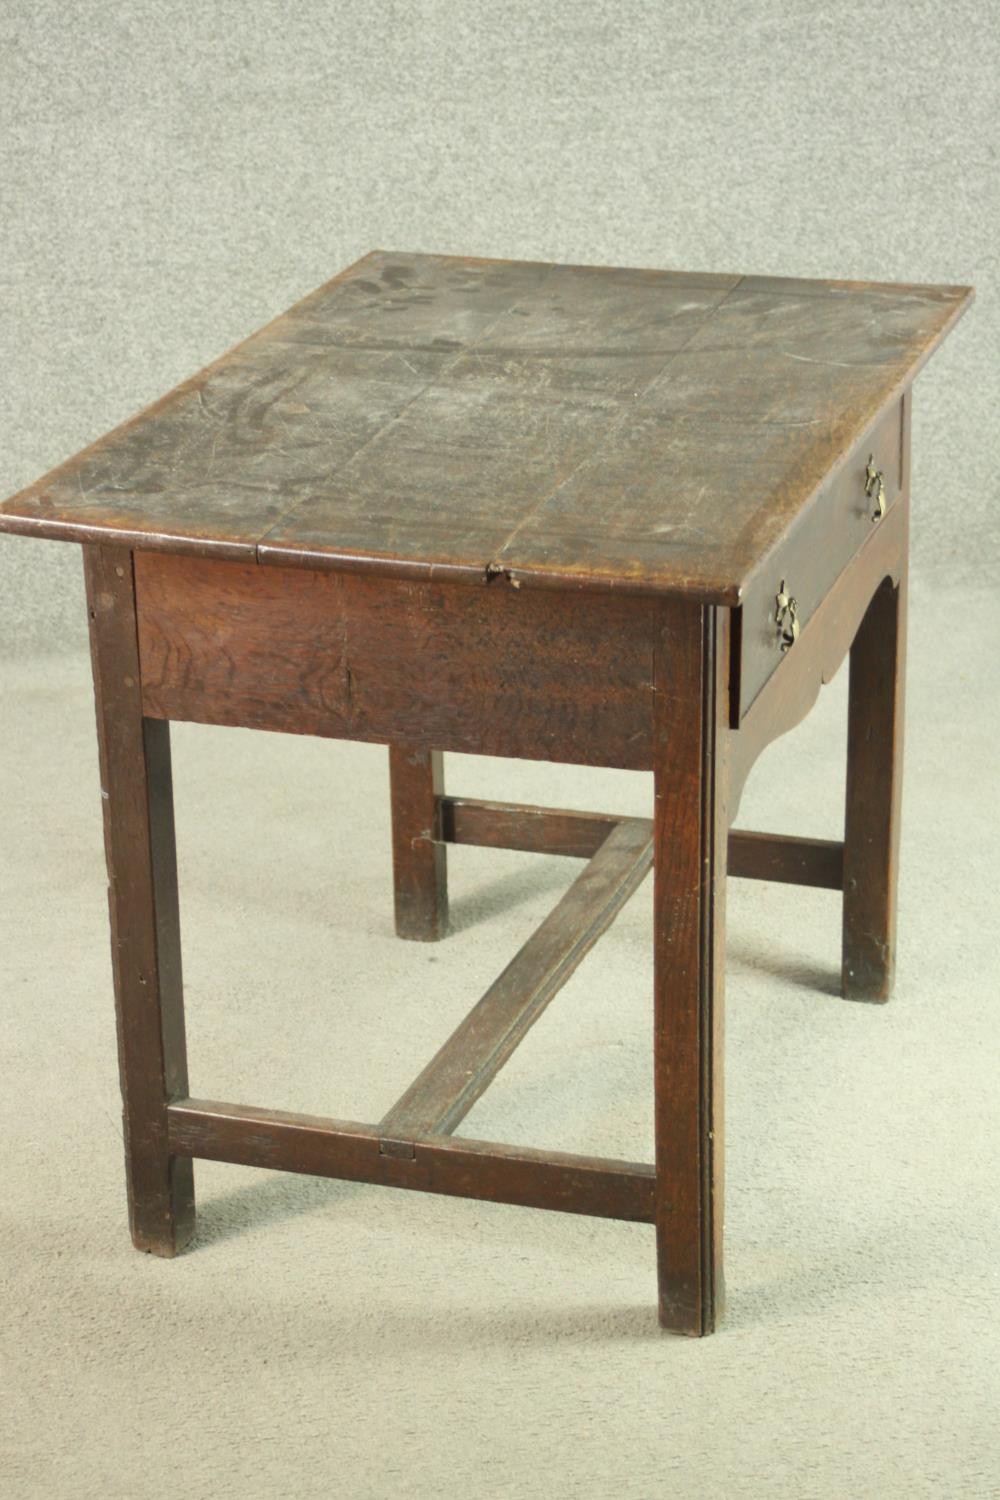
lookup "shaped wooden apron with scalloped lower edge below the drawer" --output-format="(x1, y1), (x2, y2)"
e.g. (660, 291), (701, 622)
(729, 497), (909, 818)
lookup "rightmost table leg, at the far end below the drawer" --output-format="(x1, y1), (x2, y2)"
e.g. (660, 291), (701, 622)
(843, 560), (907, 1001)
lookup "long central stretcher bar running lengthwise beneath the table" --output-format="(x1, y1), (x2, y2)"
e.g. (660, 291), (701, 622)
(381, 821), (652, 1145)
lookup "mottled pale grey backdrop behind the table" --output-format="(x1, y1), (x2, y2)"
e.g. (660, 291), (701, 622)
(0, 0), (1000, 653)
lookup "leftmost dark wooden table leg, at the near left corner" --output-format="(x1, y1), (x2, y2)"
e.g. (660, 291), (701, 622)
(84, 546), (195, 1256)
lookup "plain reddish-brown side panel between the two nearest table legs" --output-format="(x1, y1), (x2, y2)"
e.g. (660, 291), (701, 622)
(136, 552), (654, 768)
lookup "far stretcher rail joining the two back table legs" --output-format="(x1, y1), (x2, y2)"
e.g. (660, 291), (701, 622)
(439, 797), (844, 891)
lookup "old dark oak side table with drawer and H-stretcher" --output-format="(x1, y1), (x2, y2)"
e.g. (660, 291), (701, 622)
(0, 251), (972, 1334)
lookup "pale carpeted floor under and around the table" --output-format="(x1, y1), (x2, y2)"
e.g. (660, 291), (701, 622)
(0, 587), (1000, 1500)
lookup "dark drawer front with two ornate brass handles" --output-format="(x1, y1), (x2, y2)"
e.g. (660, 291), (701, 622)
(733, 401), (904, 719)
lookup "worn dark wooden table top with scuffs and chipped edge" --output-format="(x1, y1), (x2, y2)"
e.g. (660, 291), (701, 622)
(0, 251), (972, 605)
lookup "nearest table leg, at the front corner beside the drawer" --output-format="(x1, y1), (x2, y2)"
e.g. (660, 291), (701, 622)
(654, 605), (729, 1335)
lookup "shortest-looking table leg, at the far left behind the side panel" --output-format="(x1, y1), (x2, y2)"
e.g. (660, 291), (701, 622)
(388, 744), (448, 942)
